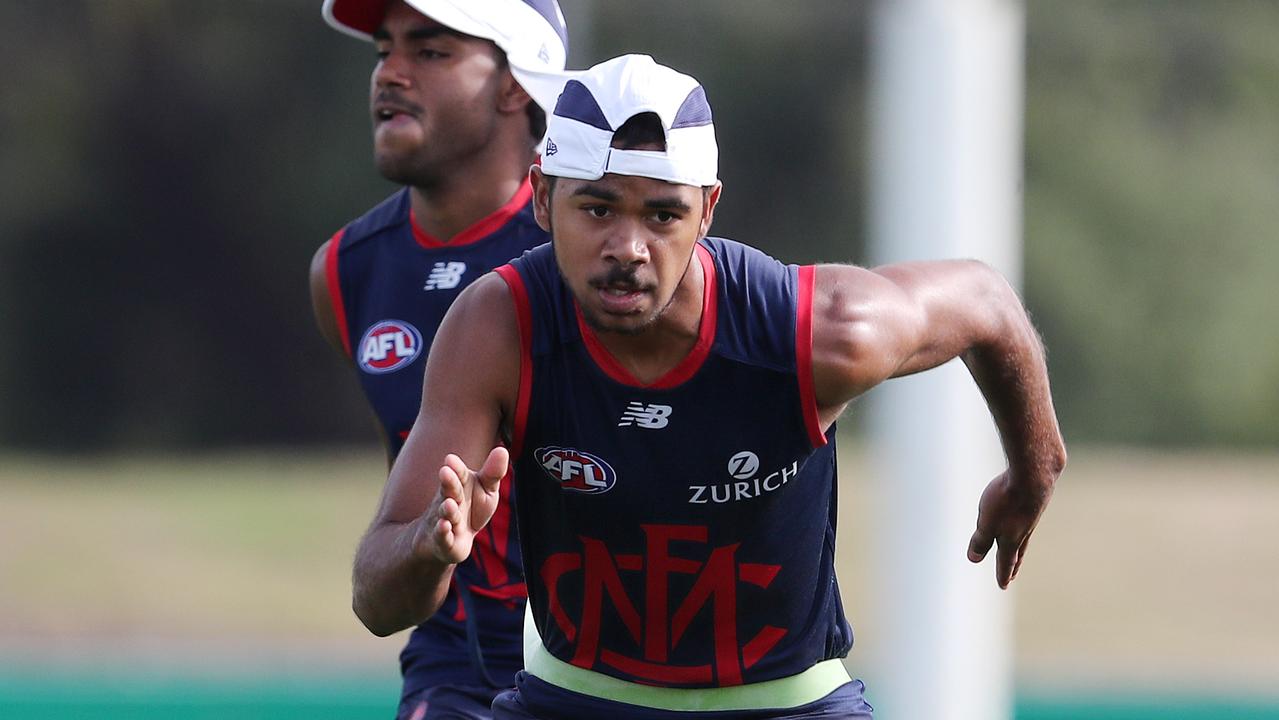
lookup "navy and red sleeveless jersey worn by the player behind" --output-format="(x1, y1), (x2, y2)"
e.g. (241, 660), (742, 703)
(326, 180), (549, 696)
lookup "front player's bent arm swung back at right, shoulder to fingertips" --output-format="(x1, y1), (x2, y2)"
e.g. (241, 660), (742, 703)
(813, 261), (1065, 587)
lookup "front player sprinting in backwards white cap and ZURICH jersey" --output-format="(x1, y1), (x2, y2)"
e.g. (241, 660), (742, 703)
(354, 56), (1065, 720)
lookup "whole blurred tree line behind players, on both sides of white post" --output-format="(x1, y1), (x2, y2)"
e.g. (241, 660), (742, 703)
(0, 0), (1279, 450)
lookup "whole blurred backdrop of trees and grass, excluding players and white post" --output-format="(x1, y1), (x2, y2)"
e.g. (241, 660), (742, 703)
(0, 0), (1279, 719)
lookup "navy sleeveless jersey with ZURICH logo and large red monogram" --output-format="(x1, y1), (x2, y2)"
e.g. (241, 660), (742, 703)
(498, 238), (852, 688)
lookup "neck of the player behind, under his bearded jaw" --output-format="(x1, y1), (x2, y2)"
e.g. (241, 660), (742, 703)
(409, 145), (535, 244)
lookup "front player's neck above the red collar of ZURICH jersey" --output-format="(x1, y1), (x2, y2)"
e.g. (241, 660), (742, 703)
(585, 252), (706, 385)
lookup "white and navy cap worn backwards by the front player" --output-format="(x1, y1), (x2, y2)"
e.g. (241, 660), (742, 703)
(542, 55), (719, 187)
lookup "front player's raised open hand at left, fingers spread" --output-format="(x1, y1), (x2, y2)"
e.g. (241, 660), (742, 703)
(416, 448), (510, 564)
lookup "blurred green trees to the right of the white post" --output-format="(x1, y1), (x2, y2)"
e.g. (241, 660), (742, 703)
(1026, 0), (1279, 446)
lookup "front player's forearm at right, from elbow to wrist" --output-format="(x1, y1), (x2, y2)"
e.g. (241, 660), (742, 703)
(962, 271), (1065, 492)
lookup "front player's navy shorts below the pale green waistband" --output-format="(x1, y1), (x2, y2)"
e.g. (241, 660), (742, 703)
(492, 671), (871, 720)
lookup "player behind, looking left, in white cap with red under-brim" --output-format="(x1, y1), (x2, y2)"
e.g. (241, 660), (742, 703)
(311, 0), (567, 720)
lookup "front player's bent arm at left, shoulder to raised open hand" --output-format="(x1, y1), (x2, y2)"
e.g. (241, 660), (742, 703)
(352, 274), (519, 636)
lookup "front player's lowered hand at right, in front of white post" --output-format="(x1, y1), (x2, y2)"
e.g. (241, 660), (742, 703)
(968, 471), (1053, 590)
